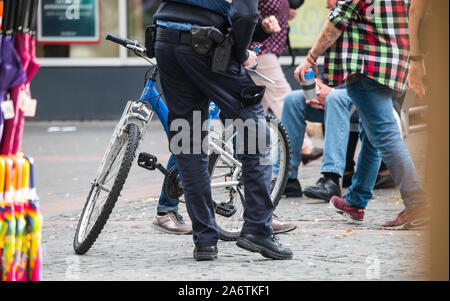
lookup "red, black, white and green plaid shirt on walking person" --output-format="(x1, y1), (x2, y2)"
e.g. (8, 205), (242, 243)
(325, 0), (409, 91)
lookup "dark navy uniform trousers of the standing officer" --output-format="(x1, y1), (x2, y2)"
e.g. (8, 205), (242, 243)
(155, 38), (274, 246)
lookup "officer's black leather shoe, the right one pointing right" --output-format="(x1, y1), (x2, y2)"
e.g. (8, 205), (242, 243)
(236, 234), (294, 259)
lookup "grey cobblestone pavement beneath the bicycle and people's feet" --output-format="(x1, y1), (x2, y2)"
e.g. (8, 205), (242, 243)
(23, 123), (428, 281)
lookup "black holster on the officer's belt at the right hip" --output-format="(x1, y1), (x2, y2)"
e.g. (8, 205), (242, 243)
(191, 26), (234, 73)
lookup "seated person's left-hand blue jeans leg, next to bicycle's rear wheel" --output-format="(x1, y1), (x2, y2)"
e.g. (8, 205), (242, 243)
(272, 90), (322, 179)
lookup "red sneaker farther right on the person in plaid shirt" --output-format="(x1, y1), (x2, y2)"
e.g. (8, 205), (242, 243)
(383, 205), (430, 230)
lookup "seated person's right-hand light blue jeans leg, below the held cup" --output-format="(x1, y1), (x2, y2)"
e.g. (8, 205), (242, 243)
(320, 89), (357, 177)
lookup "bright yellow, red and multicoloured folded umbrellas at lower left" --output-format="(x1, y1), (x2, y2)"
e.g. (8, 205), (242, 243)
(0, 154), (43, 281)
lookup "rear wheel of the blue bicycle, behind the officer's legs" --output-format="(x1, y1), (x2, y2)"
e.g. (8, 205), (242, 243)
(209, 114), (290, 241)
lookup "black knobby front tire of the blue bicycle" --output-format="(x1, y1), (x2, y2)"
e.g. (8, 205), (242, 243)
(73, 124), (139, 255)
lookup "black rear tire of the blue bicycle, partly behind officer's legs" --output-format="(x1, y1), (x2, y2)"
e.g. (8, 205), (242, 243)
(208, 114), (291, 241)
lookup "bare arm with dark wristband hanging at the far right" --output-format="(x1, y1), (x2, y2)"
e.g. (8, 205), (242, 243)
(408, 0), (427, 97)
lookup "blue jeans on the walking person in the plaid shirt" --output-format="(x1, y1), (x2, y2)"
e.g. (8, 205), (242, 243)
(345, 77), (425, 209)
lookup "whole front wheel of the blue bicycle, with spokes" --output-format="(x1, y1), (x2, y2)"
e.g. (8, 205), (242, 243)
(73, 124), (139, 255)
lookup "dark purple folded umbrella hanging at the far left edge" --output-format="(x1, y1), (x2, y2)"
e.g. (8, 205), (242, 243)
(0, 35), (27, 140)
